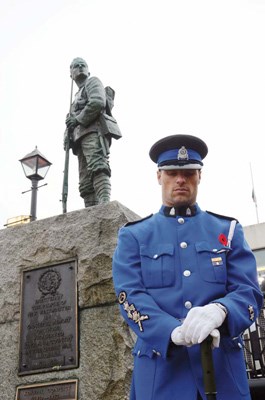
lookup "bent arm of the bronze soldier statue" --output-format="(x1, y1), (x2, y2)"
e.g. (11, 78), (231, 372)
(76, 77), (106, 127)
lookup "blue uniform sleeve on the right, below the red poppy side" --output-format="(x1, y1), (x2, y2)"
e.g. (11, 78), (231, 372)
(212, 224), (263, 337)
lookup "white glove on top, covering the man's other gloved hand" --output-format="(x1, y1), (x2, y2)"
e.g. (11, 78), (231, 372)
(181, 303), (226, 346)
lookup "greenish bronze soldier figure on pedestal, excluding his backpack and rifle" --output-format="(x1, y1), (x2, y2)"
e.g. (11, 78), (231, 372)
(65, 57), (111, 207)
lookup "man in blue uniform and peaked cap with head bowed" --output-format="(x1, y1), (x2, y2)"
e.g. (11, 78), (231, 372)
(113, 135), (263, 400)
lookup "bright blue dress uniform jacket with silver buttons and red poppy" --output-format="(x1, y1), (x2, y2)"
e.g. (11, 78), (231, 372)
(113, 205), (263, 400)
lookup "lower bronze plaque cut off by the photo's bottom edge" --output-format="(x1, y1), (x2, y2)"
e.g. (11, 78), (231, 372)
(16, 379), (77, 400)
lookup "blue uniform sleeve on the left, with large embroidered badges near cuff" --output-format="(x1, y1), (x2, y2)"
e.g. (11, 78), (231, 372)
(110, 227), (180, 358)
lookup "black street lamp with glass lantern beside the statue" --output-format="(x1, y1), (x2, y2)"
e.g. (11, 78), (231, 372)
(19, 146), (52, 222)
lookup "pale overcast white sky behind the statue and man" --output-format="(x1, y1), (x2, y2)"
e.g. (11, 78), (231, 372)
(0, 0), (265, 229)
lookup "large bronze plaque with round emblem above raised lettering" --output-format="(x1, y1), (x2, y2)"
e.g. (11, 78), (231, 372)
(18, 261), (78, 375)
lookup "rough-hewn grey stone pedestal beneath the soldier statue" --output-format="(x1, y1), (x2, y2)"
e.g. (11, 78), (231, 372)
(0, 201), (139, 400)
